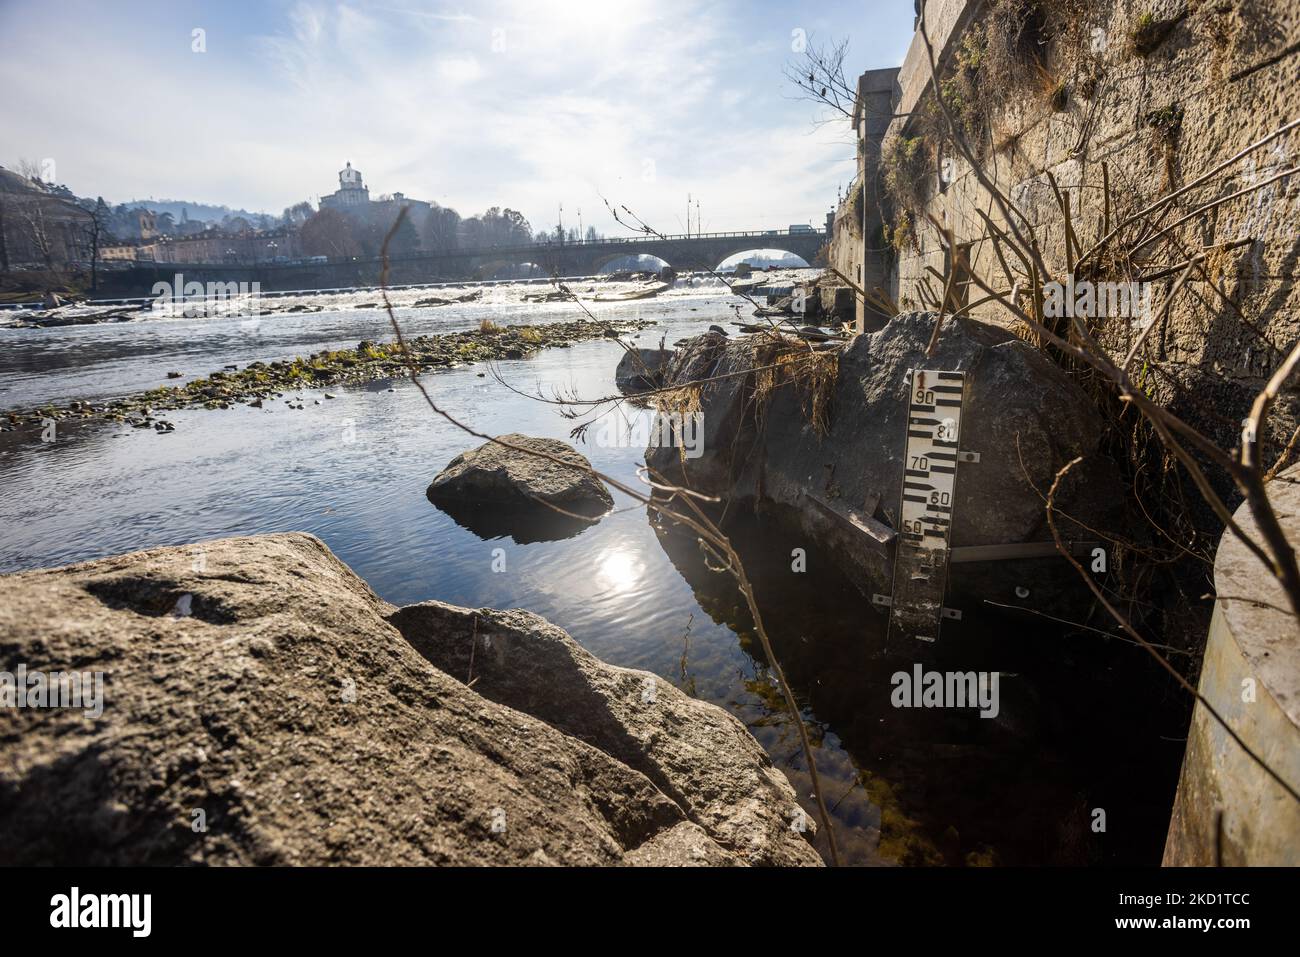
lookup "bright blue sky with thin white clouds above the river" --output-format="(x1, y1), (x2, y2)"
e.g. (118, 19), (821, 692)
(0, 0), (913, 235)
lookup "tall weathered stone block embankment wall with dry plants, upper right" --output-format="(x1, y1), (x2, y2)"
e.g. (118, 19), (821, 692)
(867, 0), (1300, 447)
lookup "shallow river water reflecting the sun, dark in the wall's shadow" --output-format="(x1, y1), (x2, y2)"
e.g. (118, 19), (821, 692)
(0, 276), (1186, 865)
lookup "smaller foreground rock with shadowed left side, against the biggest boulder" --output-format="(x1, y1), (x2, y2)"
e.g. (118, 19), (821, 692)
(389, 602), (814, 865)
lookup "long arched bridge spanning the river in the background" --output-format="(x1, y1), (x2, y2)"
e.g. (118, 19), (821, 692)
(91, 229), (829, 295)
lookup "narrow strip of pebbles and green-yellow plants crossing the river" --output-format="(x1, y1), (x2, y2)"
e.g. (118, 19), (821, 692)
(0, 319), (650, 433)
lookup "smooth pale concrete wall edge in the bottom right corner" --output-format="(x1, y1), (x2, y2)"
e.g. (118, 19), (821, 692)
(1165, 468), (1300, 867)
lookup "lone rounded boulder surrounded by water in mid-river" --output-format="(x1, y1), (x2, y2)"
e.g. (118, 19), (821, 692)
(426, 433), (614, 527)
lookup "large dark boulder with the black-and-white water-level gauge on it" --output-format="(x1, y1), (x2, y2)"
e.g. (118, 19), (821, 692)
(646, 313), (1123, 607)
